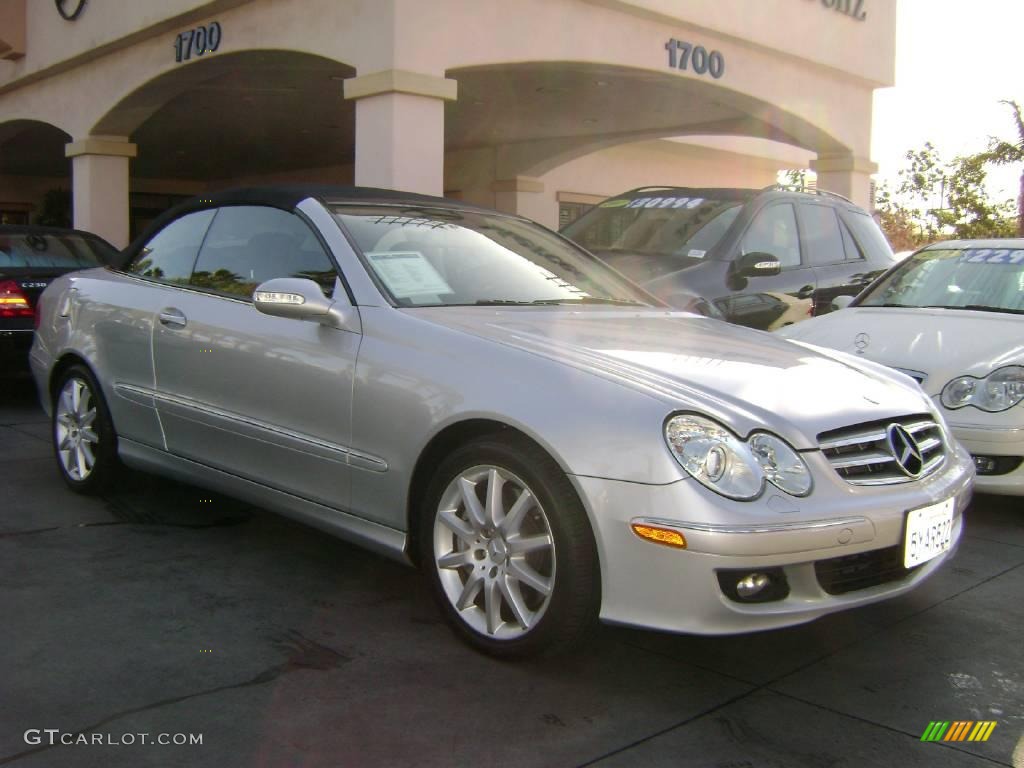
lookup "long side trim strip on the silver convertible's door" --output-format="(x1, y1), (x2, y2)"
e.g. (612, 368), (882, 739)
(114, 383), (388, 472)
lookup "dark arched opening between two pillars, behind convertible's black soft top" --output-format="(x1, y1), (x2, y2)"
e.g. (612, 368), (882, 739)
(91, 50), (355, 237)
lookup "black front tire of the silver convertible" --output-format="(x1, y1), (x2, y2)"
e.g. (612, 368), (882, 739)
(419, 434), (600, 658)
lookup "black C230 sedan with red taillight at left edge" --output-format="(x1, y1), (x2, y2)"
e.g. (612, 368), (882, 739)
(0, 226), (118, 368)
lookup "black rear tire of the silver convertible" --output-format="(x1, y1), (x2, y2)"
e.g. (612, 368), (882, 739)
(51, 364), (121, 495)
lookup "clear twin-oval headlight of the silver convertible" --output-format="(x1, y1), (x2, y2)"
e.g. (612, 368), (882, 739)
(665, 414), (811, 501)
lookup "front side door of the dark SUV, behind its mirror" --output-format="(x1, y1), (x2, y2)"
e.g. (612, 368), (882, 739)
(726, 202), (816, 329)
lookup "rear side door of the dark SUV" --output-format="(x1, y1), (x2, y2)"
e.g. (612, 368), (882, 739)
(799, 203), (870, 315)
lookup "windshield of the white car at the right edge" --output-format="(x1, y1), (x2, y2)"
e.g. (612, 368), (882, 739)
(859, 248), (1024, 314)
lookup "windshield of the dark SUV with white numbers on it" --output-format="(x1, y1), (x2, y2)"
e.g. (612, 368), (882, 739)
(562, 195), (744, 258)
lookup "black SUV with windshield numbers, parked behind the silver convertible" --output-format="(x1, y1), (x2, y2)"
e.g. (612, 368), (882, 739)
(562, 186), (893, 329)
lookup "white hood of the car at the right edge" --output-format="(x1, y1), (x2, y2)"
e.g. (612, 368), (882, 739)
(778, 307), (1024, 395)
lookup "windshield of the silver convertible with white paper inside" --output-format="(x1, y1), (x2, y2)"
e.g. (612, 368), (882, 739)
(334, 205), (656, 313)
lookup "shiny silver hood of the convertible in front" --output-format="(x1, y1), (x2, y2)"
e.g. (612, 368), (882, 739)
(403, 307), (931, 449)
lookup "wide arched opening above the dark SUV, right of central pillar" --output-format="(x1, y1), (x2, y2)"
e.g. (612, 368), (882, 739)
(445, 61), (847, 226)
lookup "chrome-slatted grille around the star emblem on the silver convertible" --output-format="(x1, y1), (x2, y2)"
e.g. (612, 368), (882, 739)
(818, 415), (946, 485)
